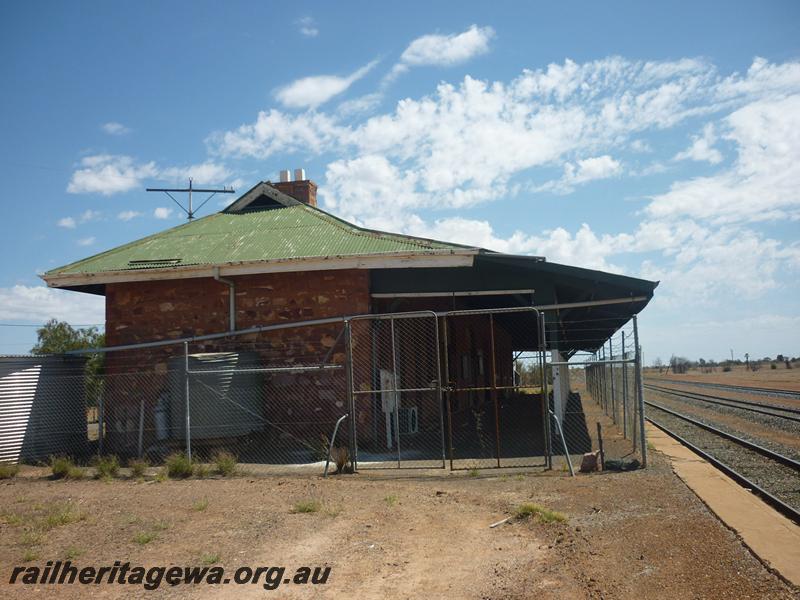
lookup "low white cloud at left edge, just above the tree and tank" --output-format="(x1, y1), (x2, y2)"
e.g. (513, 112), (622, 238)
(0, 285), (105, 324)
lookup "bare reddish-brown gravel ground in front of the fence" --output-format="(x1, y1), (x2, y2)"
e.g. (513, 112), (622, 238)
(0, 452), (797, 600)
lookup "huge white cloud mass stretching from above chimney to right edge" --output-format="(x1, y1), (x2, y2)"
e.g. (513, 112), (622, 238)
(209, 57), (800, 308)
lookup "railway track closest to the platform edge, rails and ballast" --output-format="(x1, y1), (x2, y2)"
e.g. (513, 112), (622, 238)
(645, 401), (800, 525)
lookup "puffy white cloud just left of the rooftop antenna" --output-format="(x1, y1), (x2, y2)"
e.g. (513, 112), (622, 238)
(67, 154), (158, 196)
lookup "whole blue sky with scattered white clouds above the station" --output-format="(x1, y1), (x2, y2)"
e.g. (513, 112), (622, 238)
(0, 2), (800, 360)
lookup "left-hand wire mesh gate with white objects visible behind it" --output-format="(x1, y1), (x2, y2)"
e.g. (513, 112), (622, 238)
(348, 311), (445, 469)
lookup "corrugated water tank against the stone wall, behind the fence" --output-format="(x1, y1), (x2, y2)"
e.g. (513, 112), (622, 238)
(169, 352), (266, 440)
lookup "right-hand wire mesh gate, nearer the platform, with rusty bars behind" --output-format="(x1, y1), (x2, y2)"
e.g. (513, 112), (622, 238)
(440, 308), (550, 469)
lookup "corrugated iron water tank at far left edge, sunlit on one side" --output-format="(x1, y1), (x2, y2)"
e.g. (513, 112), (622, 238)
(0, 356), (88, 463)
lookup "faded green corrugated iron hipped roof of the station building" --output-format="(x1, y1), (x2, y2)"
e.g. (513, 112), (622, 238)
(45, 184), (476, 278)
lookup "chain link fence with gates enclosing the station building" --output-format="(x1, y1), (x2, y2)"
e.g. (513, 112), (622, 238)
(0, 308), (646, 470)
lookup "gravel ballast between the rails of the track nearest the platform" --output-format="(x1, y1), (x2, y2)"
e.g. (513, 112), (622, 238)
(648, 406), (800, 510)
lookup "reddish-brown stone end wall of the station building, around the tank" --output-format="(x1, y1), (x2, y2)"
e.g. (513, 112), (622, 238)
(105, 270), (370, 455)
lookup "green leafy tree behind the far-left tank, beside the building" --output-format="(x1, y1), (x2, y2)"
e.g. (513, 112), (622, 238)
(31, 319), (106, 406)
